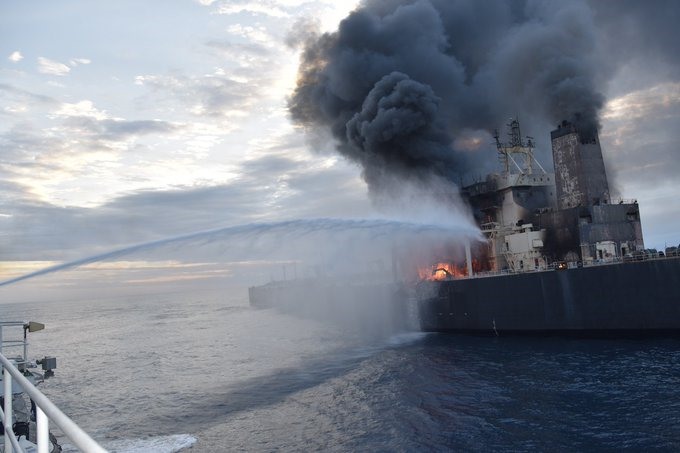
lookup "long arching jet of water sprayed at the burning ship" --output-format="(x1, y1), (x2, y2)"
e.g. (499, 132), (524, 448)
(0, 218), (478, 286)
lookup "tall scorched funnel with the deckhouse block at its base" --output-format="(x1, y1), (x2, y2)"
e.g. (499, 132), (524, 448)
(535, 121), (644, 263)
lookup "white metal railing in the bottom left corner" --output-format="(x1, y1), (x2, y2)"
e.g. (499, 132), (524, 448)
(0, 354), (106, 453)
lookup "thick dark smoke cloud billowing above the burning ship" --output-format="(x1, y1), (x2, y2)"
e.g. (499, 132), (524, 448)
(289, 0), (603, 194)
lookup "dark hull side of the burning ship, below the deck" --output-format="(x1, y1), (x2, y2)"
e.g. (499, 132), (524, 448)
(416, 258), (680, 335)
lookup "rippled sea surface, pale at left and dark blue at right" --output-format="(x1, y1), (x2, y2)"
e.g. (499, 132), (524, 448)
(0, 294), (680, 452)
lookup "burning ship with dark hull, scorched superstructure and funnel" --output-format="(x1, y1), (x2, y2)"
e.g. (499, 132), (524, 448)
(416, 121), (680, 335)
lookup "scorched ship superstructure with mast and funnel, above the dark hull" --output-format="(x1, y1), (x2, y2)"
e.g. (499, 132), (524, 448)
(463, 120), (644, 272)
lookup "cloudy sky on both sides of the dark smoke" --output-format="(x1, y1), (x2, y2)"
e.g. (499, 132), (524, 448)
(0, 0), (680, 300)
